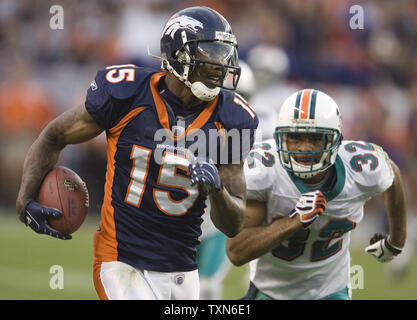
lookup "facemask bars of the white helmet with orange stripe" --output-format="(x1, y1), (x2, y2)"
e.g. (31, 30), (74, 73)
(274, 127), (342, 179)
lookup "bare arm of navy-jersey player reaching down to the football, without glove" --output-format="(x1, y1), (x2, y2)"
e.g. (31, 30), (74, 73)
(16, 105), (103, 234)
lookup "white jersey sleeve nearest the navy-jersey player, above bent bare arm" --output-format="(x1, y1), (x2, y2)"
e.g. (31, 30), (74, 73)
(240, 142), (276, 202)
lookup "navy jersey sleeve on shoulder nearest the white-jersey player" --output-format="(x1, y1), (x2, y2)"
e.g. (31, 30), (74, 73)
(216, 91), (259, 163)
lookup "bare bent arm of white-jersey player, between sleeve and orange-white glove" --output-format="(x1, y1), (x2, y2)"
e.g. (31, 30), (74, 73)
(226, 200), (303, 266)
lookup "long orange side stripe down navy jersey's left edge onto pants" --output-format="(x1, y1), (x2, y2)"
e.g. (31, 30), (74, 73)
(93, 107), (146, 298)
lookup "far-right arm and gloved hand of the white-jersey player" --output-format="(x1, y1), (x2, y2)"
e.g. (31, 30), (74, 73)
(366, 160), (407, 262)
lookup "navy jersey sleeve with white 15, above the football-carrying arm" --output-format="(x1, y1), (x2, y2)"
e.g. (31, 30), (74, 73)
(85, 65), (150, 130)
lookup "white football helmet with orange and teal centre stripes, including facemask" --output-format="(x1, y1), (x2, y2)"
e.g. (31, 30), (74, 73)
(274, 89), (342, 179)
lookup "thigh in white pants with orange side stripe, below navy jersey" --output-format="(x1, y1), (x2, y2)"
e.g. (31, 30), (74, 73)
(93, 261), (158, 300)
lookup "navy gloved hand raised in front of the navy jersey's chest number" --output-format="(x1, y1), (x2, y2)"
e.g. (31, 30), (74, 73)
(187, 155), (223, 196)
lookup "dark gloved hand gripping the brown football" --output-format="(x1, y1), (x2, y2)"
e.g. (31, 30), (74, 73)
(19, 199), (72, 240)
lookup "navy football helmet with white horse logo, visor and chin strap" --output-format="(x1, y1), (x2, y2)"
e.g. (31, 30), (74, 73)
(154, 7), (240, 101)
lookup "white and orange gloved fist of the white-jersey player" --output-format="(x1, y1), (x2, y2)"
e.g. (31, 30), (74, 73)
(289, 190), (327, 228)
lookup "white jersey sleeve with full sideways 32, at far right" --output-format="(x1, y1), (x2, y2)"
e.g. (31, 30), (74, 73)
(341, 141), (394, 196)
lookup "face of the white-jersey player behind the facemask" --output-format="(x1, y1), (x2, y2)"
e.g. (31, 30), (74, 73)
(287, 133), (323, 165)
